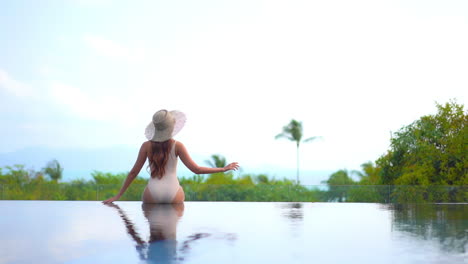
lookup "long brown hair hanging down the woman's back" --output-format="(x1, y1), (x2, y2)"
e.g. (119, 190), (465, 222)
(148, 139), (172, 179)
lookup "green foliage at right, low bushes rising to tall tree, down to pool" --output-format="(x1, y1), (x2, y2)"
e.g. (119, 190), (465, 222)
(325, 101), (468, 203)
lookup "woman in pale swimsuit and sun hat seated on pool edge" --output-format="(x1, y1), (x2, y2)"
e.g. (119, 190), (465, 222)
(103, 110), (239, 204)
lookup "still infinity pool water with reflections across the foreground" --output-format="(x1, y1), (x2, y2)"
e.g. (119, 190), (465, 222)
(0, 201), (468, 264)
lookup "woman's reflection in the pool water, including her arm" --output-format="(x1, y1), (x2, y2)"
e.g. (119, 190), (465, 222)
(109, 203), (184, 263)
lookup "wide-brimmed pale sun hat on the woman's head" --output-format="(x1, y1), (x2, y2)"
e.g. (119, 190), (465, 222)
(145, 110), (187, 142)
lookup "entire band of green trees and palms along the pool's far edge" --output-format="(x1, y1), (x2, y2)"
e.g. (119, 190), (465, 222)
(0, 101), (468, 203)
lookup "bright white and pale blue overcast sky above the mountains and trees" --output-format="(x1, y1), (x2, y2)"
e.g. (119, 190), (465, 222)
(0, 0), (468, 175)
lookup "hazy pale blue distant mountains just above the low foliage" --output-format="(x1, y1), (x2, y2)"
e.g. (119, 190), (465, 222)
(0, 146), (333, 185)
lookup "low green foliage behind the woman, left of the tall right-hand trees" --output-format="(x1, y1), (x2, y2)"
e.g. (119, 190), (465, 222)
(0, 166), (323, 202)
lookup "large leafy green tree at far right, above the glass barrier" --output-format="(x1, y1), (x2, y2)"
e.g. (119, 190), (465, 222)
(377, 101), (468, 186)
